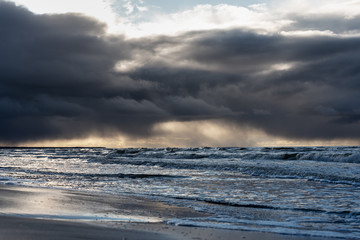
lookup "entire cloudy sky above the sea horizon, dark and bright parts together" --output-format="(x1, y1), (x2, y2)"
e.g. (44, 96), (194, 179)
(0, 0), (360, 147)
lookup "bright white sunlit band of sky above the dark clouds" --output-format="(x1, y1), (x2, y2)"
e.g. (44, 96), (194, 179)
(9, 0), (360, 38)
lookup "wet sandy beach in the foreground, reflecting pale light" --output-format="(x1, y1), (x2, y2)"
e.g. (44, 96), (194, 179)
(0, 185), (334, 240)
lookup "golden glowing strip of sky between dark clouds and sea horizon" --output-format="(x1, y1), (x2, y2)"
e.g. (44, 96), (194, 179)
(11, 120), (360, 148)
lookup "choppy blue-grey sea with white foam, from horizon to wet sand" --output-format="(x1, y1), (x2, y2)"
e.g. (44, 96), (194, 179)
(0, 146), (360, 239)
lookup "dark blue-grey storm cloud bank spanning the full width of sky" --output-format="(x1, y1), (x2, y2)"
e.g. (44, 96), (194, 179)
(0, 1), (360, 144)
